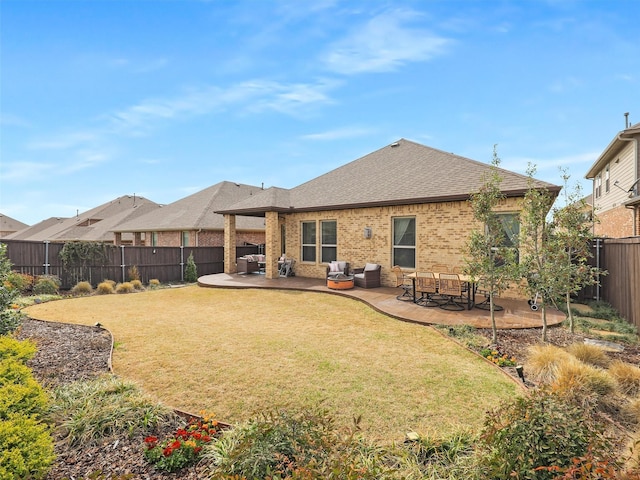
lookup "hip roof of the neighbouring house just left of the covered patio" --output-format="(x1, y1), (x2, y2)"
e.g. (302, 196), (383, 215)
(113, 181), (264, 232)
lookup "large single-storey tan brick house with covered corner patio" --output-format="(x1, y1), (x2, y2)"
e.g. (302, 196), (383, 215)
(219, 139), (561, 286)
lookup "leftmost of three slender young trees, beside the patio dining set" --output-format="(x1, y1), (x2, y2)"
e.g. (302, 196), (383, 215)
(466, 146), (517, 344)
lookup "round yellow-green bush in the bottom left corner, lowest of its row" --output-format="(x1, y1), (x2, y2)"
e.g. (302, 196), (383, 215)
(0, 415), (55, 480)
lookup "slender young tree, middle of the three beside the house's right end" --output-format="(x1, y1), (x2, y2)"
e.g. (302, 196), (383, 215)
(520, 164), (566, 342)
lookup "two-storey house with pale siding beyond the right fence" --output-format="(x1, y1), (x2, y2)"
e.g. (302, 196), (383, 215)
(585, 123), (640, 238)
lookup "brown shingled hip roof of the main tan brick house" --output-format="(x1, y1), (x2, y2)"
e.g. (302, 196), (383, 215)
(218, 139), (561, 215)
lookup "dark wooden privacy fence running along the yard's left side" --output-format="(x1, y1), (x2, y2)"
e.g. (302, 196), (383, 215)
(2, 240), (258, 289)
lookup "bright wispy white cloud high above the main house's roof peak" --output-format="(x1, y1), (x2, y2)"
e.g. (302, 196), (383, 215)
(324, 10), (450, 75)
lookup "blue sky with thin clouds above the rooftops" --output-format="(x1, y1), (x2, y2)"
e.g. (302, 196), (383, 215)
(0, 0), (640, 224)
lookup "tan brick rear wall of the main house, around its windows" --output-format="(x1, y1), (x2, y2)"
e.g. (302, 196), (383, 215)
(285, 199), (518, 286)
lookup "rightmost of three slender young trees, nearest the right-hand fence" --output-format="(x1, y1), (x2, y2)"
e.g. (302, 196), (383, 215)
(553, 169), (606, 333)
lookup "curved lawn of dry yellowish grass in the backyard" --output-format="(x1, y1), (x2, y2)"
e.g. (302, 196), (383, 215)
(25, 286), (521, 441)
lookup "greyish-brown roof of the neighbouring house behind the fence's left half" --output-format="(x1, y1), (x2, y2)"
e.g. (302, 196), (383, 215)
(6, 195), (160, 244)
